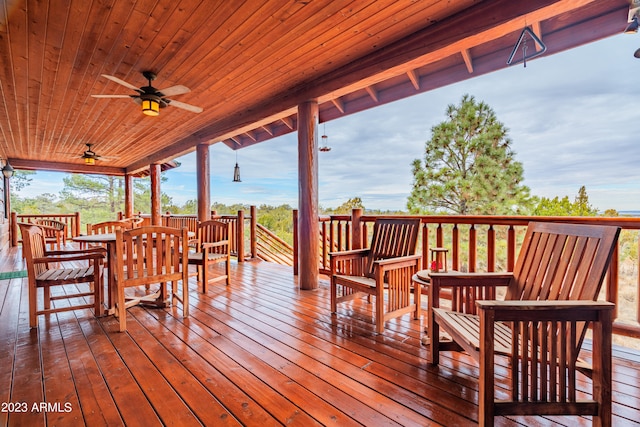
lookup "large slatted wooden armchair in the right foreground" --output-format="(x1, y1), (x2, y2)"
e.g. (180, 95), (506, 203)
(427, 223), (620, 426)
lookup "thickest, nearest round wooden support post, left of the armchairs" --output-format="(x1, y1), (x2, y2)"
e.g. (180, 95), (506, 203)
(298, 100), (320, 289)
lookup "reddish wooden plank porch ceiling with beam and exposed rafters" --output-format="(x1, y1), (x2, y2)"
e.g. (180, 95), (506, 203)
(0, 0), (629, 174)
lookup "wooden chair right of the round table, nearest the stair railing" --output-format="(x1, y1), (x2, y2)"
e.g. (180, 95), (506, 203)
(189, 220), (231, 293)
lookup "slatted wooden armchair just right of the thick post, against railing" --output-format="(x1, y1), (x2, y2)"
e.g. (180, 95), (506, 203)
(329, 218), (421, 333)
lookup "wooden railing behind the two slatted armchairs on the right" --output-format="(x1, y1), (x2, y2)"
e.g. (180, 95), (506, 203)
(294, 209), (640, 338)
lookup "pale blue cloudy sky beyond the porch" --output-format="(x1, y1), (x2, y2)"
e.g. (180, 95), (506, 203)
(19, 34), (640, 211)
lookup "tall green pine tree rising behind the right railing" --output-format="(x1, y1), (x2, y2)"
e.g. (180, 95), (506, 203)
(407, 95), (532, 215)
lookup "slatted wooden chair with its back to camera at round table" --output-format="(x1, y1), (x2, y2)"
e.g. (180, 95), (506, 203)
(115, 226), (189, 332)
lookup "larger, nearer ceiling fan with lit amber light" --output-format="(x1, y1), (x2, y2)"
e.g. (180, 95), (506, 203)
(91, 71), (203, 116)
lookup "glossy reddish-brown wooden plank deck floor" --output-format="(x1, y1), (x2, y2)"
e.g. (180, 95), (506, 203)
(0, 246), (640, 427)
